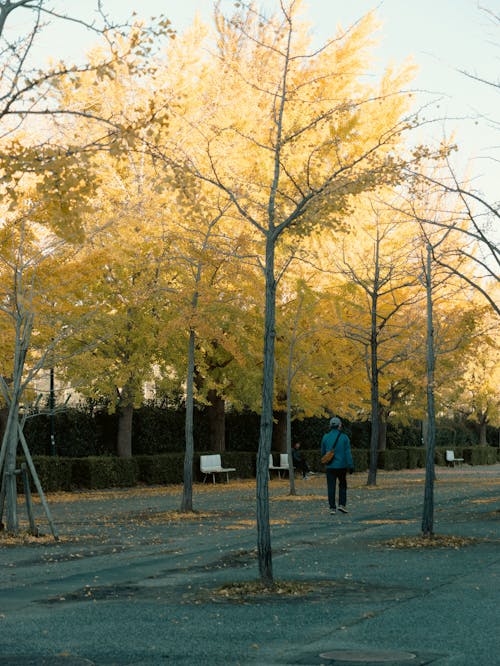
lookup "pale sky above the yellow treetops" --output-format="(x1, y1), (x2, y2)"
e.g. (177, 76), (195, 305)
(25, 0), (500, 200)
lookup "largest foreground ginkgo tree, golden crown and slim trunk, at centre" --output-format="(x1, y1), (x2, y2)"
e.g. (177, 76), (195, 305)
(140, 0), (434, 584)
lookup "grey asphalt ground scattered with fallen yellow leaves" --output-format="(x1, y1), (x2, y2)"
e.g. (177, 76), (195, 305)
(0, 465), (500, 666)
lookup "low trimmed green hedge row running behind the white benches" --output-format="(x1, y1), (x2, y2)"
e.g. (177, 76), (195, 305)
(19, 446), (500, 492)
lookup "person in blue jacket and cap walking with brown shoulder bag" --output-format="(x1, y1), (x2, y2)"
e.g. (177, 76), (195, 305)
(321, 416), (354, 513)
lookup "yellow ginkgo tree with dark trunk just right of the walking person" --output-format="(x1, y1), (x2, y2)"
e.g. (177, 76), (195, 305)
(320, 198), (421, 485)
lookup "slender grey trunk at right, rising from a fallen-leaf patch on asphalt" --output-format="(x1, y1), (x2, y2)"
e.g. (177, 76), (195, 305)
(422, 246), (436, 537)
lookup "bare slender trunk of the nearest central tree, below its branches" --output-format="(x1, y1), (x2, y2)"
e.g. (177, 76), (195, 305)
(257, 234), (276, 586)
